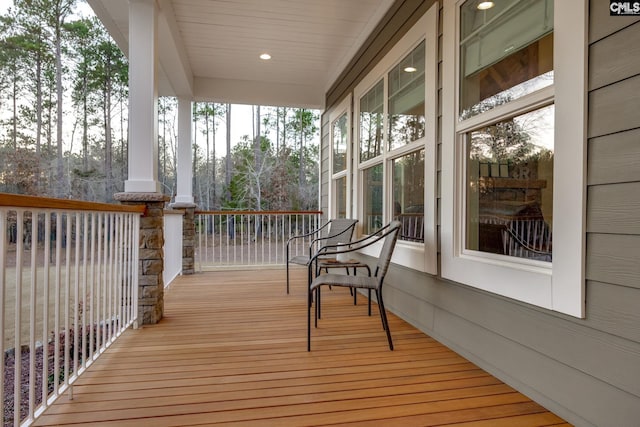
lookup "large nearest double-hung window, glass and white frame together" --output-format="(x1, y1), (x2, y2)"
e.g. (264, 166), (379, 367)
(442, 0), (586, 317)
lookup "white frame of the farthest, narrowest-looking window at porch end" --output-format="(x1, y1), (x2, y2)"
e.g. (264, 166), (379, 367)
(328, 94), (353, 218)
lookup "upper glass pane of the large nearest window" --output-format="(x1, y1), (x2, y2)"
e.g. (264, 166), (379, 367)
(459, 0), (553, 120)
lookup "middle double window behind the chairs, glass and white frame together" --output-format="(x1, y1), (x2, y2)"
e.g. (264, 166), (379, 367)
(354, 6), (437, 273)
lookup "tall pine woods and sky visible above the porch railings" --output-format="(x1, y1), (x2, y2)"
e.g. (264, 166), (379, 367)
(0, 0), (319, 210)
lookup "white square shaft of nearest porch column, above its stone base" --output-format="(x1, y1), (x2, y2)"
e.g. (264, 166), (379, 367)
(124, 0), (161, 193)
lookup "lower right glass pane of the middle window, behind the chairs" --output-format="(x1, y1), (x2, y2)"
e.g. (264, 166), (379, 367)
(393, 150), (424, 242)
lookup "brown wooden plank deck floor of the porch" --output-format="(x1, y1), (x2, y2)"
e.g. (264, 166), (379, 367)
(36, 269), (569, 427)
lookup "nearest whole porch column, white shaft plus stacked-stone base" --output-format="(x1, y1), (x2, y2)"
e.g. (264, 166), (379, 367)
(114, 0), (169, 325)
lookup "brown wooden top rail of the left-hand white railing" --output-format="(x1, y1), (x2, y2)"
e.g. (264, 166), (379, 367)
(0, 193), (145, 214)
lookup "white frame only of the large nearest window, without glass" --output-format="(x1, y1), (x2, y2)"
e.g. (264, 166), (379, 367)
(441, 0), (588, 318)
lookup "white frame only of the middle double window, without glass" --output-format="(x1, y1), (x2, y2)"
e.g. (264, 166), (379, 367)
(352, 4), (438, 274)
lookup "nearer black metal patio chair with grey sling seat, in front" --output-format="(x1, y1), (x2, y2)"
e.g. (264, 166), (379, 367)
(307, 221), (401, 351)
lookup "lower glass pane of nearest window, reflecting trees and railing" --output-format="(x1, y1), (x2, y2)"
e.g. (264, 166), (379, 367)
(466, 105), (554, 261)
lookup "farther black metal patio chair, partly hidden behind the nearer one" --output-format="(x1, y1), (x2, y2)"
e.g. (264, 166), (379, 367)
(287, 218), (358, 293)
